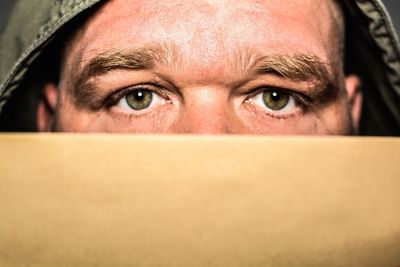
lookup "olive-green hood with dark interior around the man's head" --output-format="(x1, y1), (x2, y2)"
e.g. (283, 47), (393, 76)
(0, 0), (400, 135)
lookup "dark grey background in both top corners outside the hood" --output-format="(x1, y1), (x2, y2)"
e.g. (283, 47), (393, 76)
(0, 0), (400, 44)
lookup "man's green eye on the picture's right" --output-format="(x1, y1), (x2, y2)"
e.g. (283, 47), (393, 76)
(250, 88), (296, 114)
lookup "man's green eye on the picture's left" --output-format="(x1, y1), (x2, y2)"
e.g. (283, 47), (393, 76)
(116, 89), (165, 112)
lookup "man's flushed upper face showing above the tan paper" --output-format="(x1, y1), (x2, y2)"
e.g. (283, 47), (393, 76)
(39, 0), (362, 134)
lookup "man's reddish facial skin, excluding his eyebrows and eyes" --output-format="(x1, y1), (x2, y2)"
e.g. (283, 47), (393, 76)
(43, 0), (360, 134)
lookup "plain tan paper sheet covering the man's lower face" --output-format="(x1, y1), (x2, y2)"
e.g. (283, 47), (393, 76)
(0, 135), (400, 267)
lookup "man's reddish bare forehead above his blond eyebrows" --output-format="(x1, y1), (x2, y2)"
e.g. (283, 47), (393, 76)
(69, 0), (336, 71)
